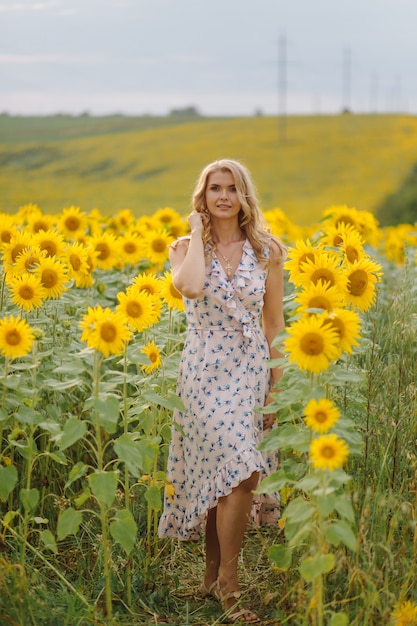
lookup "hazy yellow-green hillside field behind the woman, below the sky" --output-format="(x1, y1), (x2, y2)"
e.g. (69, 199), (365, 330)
(0, 114), (417, 225)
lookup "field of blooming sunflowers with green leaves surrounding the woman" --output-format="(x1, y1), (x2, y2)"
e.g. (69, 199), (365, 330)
(0, 204), (417, 626)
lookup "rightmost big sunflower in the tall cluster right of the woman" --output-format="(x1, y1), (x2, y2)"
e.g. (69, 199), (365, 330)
(345, 257), (382, 311)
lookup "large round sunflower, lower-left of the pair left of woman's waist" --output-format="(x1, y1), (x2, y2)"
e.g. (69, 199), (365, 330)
(79, 306), (132, 357)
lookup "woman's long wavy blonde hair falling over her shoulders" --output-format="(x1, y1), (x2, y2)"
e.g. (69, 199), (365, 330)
(193, 159), (286, 265)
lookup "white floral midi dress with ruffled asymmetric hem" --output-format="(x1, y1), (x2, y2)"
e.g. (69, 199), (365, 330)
(158, 240), (279, 540)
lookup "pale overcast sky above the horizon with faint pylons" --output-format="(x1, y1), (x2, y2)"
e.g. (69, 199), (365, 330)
(0, 0), (417, 115)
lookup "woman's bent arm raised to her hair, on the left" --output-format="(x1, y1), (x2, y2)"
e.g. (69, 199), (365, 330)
(169, 211), (206, 299)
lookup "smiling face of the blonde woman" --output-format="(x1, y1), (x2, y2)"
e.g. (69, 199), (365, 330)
(206, 170), (241, 219)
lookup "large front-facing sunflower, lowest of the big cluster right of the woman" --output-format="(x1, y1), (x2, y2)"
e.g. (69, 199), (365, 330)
(284, 315), (339, 372)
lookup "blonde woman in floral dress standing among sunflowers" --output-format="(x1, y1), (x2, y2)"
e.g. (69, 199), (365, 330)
(159, 159), (285, 622)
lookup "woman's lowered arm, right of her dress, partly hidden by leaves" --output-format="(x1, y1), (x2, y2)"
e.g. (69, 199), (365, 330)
(262, 242), (285, 428)
